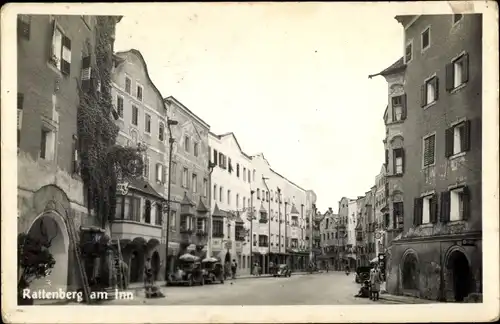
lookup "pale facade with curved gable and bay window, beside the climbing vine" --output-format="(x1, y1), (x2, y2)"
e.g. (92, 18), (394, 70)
(111, 49), (168, 282)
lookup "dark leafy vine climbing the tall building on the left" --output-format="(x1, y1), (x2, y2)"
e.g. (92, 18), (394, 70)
(77, 16), (143, 228)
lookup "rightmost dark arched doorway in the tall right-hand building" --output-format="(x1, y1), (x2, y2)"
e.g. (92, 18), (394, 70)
(446, 250), (473, 302)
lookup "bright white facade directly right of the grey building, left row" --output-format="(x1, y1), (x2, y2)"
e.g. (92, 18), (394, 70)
(208, 132), (253, 273)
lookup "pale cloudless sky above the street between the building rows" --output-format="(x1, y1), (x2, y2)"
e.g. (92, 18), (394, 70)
(115, 3), (403, 212)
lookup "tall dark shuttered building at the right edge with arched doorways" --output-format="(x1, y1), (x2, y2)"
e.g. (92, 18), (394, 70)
(387, 14), (482, 301)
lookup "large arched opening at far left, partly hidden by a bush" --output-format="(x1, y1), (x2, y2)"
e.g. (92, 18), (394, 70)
(28, 211), (69, 291)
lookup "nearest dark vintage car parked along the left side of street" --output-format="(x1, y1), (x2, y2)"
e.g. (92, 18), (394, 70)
(167, 254), (205, 286)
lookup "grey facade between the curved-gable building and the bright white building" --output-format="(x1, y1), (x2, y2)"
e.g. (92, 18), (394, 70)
(164, 96), (211, 271)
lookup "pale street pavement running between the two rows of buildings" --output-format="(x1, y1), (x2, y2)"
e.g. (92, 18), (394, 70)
(106, 271), (434, 305)
